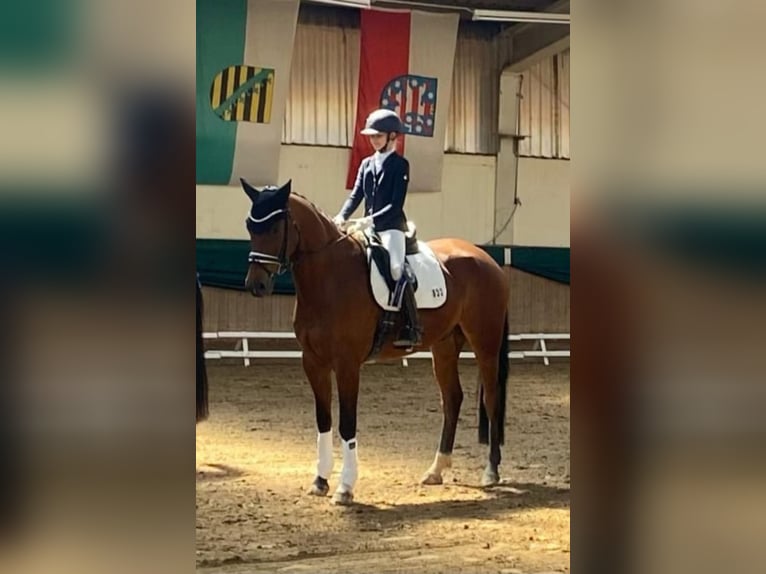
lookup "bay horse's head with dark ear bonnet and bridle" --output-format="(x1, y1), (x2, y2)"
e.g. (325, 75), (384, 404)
(240, 179), (298, 297)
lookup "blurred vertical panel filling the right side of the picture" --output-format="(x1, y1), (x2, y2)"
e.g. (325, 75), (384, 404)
(571, 0), (766, 574)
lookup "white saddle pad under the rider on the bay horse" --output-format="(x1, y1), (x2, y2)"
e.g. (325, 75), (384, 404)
(368, 241), (447, 311)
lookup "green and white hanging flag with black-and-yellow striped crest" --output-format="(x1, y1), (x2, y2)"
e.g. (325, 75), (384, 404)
(197, 0), (299, 185)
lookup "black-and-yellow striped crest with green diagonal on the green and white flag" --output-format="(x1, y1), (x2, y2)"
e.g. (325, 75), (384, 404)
(210, 66), (274, 124)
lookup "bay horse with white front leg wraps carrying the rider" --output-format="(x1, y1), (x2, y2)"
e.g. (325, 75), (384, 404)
(241, 179), (510, 504)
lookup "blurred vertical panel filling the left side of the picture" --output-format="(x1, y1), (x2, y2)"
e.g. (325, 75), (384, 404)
(0, 0), (195, 574)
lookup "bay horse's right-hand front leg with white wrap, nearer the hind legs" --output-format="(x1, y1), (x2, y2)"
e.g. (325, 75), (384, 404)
(333, 361), (361, 505)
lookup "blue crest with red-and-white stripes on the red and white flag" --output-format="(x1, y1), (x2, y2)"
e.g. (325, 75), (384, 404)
(380, 74), (438, 137)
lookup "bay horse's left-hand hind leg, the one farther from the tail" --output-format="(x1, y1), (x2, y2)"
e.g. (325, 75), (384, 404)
(420, 328), (465, 484)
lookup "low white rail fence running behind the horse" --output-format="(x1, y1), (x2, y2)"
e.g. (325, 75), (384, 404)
(202, 331), (570, 367)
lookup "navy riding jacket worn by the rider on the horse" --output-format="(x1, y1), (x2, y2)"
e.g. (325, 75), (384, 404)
(340, 152), (410, 235)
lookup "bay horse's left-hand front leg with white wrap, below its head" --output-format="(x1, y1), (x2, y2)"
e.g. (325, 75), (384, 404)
(303, 351), (333, 496)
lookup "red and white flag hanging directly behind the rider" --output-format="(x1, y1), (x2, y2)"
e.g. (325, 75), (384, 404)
(346, 10), (459, 191)
